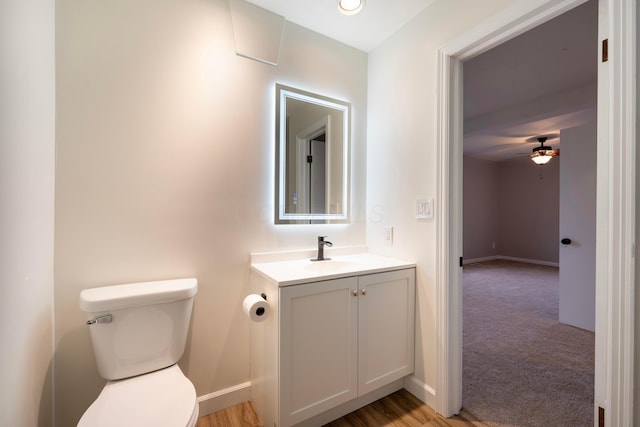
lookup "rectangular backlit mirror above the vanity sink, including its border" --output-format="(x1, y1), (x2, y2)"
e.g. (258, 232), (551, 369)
(275, 84), (351, 224)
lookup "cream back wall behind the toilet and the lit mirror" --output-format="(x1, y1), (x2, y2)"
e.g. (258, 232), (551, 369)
(55, 0), (367, 426)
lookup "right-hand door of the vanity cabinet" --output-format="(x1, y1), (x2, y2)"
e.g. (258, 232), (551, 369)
(358, 269), (415, 395)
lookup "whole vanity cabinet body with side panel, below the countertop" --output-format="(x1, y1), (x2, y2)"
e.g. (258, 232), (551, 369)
(251, 254), (415, 427)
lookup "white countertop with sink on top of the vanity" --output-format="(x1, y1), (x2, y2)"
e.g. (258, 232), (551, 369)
(251, 252), (415, 286)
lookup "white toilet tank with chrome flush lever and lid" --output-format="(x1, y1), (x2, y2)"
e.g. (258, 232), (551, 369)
(80, 278), (198, 380)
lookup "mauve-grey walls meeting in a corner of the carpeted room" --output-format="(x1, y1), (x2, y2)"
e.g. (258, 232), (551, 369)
(463, 157), (560, 263)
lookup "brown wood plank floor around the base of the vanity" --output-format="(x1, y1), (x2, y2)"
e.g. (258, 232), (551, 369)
(197, 390), (482, 427)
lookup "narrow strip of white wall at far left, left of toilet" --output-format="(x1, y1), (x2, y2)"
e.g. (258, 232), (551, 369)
(0, 0), (55, 427)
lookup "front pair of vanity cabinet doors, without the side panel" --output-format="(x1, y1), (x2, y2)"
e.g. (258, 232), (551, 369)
(280, 269), (415, 426)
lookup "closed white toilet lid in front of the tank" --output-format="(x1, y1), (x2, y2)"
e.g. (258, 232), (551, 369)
(78, 365), (198, 427)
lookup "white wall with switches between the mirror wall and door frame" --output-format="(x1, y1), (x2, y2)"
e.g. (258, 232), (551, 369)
(367, 0), (516, 404)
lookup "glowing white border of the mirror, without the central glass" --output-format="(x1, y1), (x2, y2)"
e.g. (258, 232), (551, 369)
(275, 84), (351, 224)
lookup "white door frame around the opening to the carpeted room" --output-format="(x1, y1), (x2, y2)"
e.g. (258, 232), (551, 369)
(435, 0), (636, 425)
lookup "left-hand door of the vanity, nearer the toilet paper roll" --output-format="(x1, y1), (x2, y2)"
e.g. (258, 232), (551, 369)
(280, 277), (359, 426)
